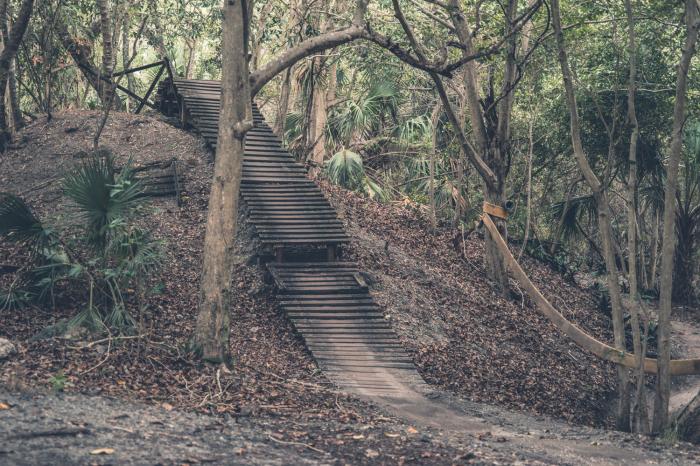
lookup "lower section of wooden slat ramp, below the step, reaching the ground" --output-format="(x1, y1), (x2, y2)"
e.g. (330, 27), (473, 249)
(268, 262), (423, 396)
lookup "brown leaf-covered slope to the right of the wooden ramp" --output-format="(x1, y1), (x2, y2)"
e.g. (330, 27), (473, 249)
(324, 184), (614, 424)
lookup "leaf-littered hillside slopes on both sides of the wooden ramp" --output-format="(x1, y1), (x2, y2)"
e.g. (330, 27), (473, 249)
(0, 112), (613, 424)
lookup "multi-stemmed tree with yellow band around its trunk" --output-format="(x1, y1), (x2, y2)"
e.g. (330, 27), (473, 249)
(392, 0), (541, 294)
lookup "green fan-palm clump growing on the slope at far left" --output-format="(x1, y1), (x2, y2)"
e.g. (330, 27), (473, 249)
(0, 152), (162, 335)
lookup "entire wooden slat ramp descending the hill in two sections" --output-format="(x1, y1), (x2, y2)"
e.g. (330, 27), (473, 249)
(158, 79), (425, 397)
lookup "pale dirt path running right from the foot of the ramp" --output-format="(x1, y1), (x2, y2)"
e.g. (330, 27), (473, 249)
(364, 376), (700, 465)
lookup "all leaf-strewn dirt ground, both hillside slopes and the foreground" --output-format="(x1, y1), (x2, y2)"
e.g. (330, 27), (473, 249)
(0, 112), (698, 464)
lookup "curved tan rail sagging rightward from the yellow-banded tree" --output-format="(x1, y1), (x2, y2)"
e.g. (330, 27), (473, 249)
(481, 214), (700, 375)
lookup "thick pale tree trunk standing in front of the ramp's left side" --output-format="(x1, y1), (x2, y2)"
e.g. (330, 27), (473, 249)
(193, 0), (253, 362)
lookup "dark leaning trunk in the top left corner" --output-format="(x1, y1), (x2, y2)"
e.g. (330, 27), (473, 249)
(0, 0), (34, 152)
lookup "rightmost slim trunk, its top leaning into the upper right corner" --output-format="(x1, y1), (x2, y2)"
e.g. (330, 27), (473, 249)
(652, 0), (700, 432)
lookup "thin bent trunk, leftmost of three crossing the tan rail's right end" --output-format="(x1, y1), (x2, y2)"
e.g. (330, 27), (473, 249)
(552, 0), (630, 430)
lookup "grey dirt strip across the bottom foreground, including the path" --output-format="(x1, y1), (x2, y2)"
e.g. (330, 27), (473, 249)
(0, 387), (700, 465)
